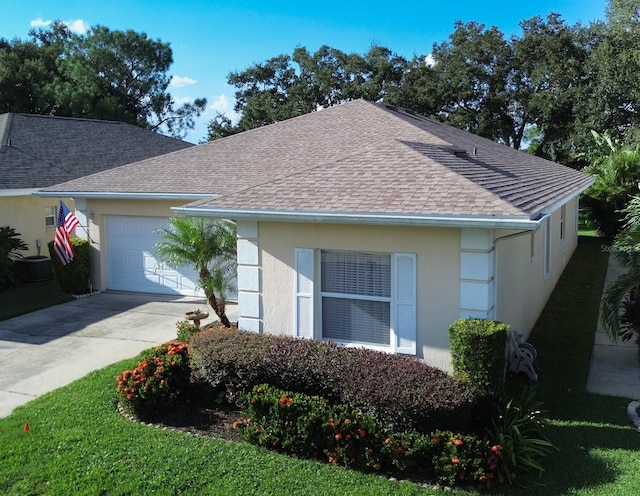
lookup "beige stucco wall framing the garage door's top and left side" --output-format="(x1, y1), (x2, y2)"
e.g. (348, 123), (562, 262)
(82, 199), (187, 291)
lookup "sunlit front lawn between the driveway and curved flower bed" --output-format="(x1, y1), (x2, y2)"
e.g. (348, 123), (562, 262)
(0, 359), (436, 496)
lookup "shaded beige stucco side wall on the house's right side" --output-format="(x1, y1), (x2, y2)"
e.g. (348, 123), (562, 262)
(495, 201), (578, 336)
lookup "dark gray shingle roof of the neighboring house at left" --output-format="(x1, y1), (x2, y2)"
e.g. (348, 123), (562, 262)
(0, 113), (193, 190)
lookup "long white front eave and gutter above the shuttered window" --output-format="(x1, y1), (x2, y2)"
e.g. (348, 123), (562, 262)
(172, 206), (540, 231)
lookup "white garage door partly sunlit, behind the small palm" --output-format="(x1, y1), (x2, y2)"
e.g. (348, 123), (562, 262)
(106, 216), (203, 296)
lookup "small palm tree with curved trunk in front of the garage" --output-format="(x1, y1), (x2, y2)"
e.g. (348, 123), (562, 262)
(156, 217), (236, 327)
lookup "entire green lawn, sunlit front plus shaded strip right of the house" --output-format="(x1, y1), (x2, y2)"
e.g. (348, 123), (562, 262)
(0, 238), (640, 496)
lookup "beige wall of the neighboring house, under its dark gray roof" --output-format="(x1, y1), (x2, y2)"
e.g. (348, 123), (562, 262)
(0, 194), (74, 257)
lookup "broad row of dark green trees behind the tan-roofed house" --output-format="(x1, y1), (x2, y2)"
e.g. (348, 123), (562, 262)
(208, 0), (640, 167)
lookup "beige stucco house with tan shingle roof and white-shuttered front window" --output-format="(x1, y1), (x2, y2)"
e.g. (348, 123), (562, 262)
(40, 100), (591, 370)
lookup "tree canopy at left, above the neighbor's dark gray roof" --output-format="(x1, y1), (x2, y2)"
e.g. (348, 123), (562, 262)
(0, 22), (206, 137)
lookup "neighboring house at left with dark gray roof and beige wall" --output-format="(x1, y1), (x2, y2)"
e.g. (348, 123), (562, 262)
(0, 113), (193, 256)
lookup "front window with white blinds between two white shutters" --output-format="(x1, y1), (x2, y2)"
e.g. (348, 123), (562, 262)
(320, 251), (391, 346)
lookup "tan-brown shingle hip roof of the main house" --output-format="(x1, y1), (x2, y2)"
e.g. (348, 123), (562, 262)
(38, 100), (591, 222)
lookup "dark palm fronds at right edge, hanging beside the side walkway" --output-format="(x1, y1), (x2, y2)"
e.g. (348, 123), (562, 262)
(600, 196), (640, 341)
